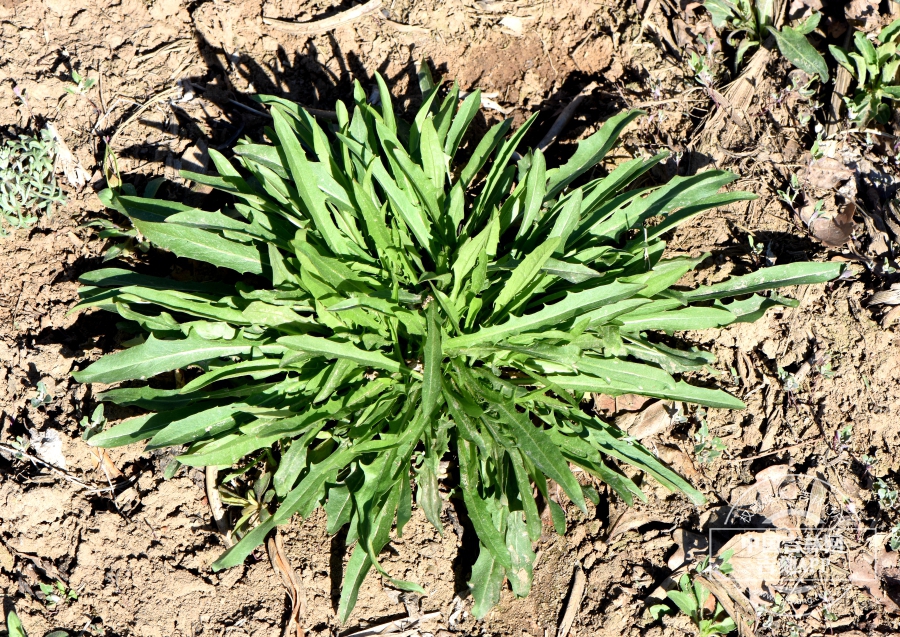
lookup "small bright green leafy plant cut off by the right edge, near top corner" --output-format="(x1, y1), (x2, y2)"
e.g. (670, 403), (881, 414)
(828, 19), (900, 127)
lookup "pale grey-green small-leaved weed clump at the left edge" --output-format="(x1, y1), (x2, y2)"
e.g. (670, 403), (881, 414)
(0, 130), (65, 236)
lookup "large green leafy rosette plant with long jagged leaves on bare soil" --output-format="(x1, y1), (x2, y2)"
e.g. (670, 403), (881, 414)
(75, 68), (842, 621)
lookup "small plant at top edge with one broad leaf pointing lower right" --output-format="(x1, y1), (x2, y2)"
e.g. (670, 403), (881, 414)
(703, 0), (828, 82)
